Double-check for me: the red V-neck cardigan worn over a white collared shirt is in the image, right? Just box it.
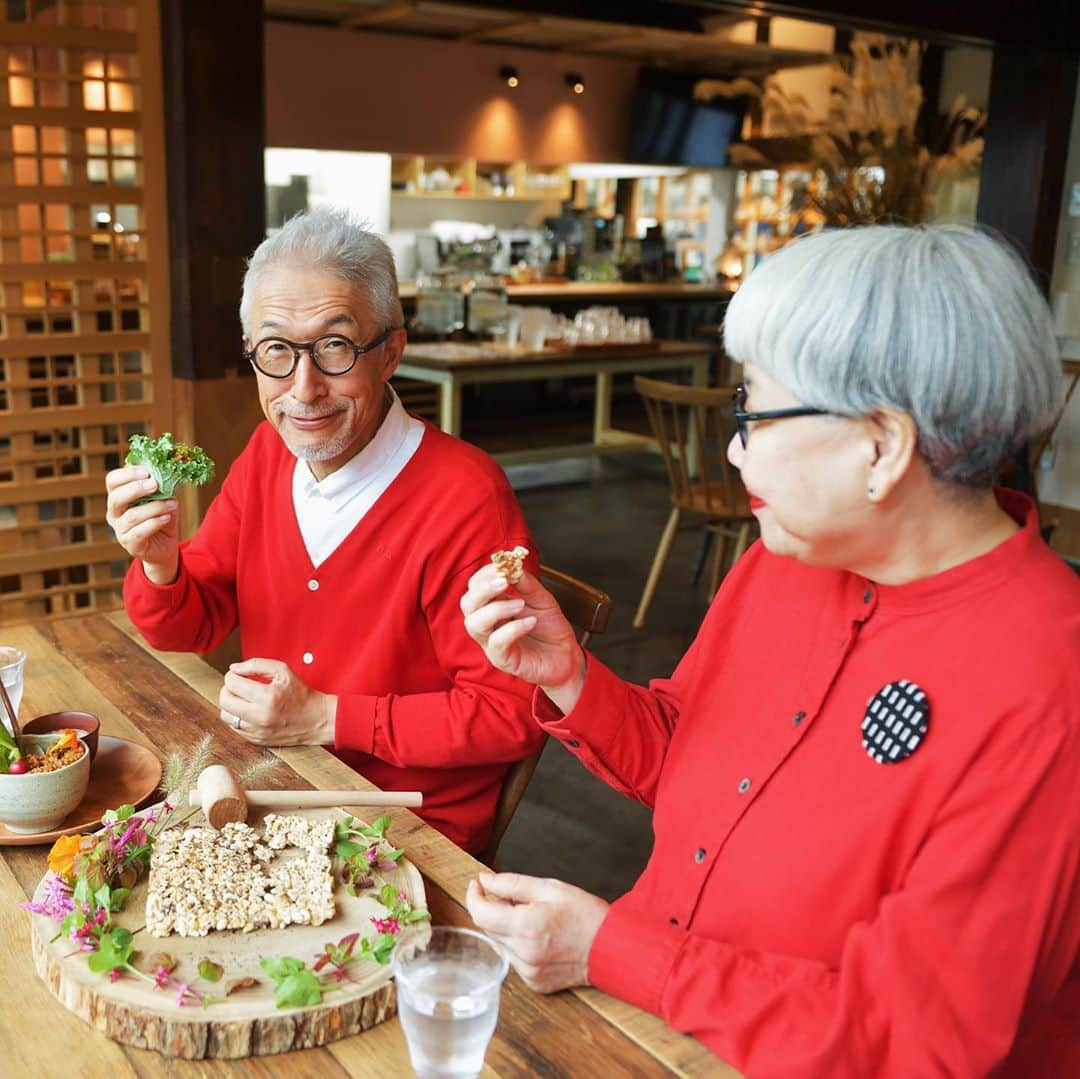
[124,422,542,851]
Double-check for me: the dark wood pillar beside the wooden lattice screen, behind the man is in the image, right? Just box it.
[161,0,266,379]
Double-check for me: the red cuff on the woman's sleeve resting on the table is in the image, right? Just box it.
[589,898,687,1016]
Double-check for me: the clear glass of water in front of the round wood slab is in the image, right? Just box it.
[393,926,510,1079]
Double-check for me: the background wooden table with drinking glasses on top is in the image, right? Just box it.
[397,341,708,464]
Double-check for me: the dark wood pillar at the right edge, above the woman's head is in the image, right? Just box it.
[977,45,1078,291]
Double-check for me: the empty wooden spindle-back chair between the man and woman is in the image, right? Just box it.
[634,376,754,630]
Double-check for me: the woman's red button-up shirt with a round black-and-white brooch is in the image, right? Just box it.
[534,493,1080,1079]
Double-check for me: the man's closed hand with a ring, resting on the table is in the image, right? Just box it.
[218,659,337,745]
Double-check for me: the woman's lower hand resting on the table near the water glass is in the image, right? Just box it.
[465,873,608,993]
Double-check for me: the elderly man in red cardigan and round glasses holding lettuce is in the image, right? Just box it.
[106,211,540,851]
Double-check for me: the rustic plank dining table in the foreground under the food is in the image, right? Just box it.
[0,612,737,1079]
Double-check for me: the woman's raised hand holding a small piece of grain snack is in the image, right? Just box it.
[461,566,585,713]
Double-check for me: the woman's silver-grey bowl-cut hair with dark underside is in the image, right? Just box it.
[724,226,1064,487]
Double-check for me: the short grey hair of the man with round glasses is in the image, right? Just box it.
[240,207,405,337]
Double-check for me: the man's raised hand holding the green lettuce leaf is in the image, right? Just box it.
[105,466,180,584]
